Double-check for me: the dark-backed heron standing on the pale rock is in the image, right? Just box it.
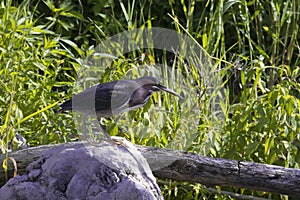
[60,76,182,139]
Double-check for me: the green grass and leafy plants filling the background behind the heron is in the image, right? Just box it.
[0,0,300,199]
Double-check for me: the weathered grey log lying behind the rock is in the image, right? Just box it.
[0,143,300,196]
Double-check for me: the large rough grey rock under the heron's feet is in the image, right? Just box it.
[0,139,163,200]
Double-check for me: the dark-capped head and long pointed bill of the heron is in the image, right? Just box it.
[136,76,183,99]
